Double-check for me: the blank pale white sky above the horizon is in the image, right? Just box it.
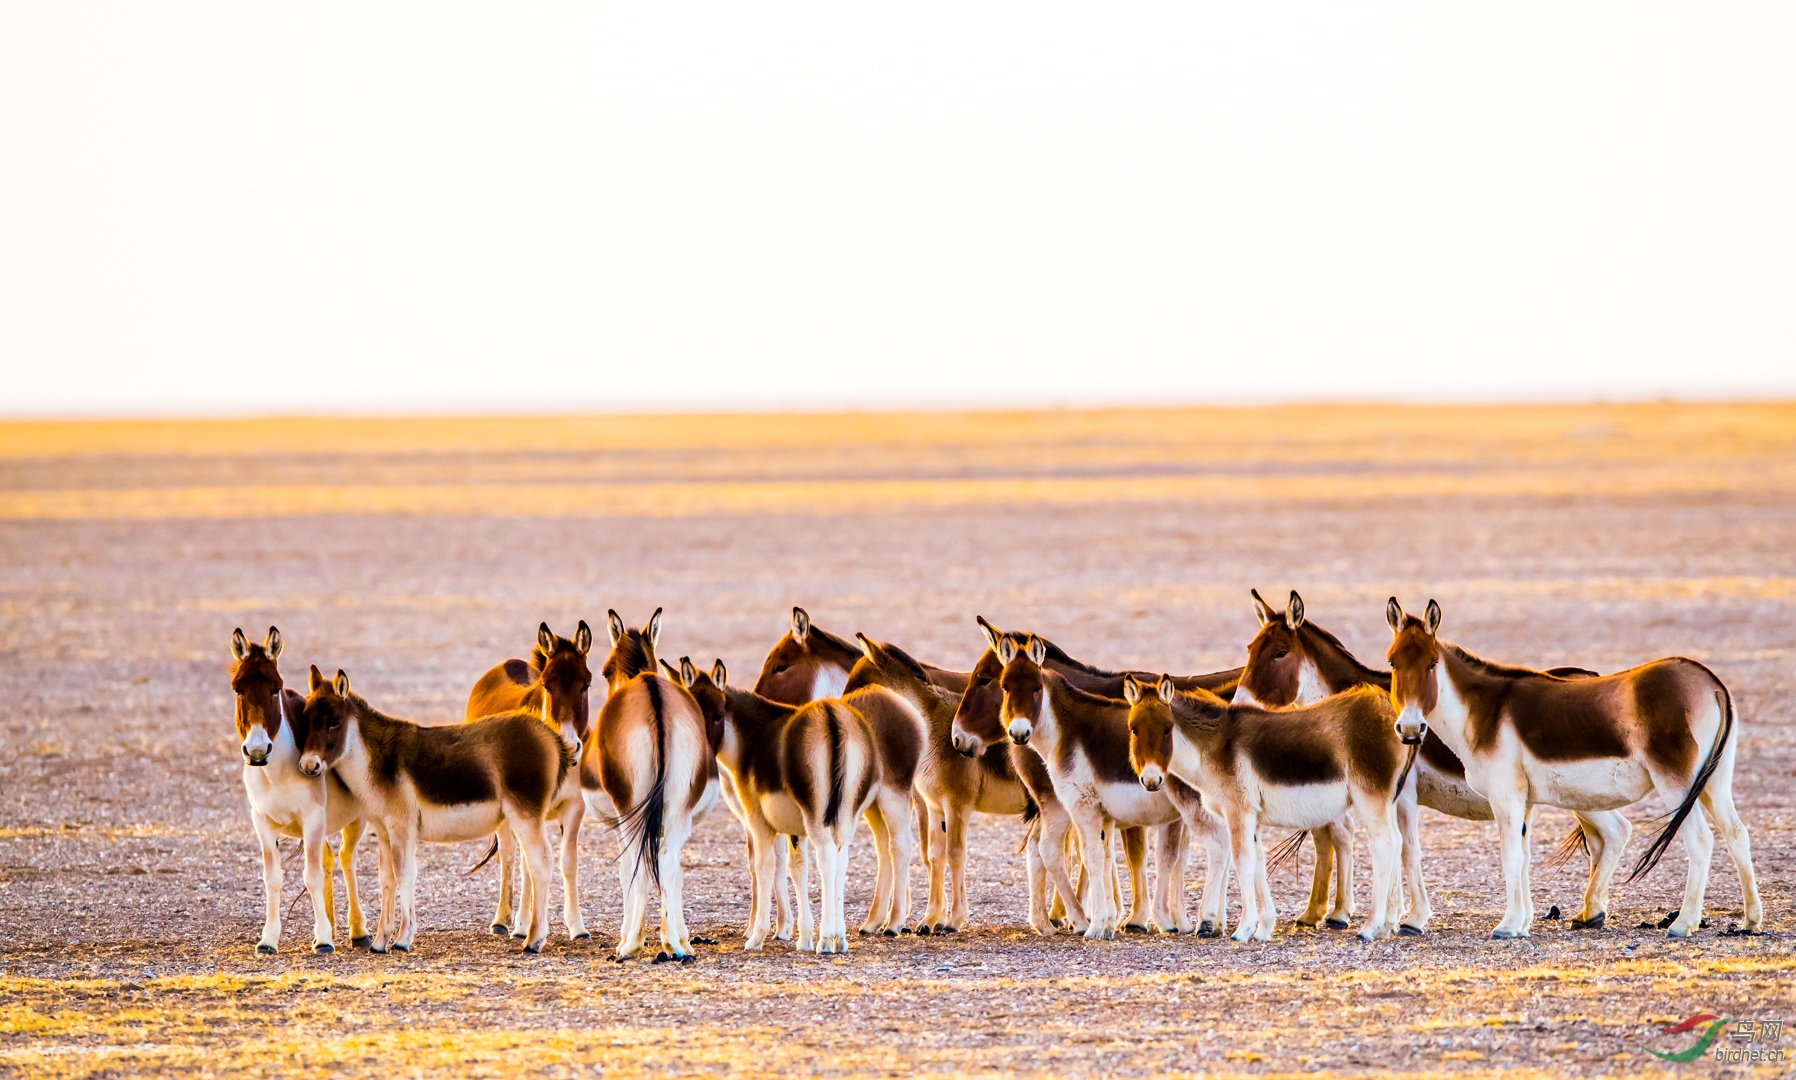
[0,0,1796,415]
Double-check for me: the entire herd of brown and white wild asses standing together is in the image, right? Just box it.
[232,591,1762,960]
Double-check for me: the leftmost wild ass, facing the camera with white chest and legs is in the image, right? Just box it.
[230,627,368,952]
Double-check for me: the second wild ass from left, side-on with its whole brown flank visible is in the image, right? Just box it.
[300,667,575,952]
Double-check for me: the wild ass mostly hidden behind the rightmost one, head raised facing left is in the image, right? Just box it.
[1234,589,1633,934]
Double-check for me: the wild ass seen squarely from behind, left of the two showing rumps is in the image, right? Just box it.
[580,607,718,963]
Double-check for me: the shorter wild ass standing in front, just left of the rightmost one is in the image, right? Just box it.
[1123,676,1422,942]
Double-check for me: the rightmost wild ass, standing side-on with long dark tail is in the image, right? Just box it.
[1385,597,1764,938]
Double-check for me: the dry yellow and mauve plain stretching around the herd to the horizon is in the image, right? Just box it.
[0,404,1796,1078]
